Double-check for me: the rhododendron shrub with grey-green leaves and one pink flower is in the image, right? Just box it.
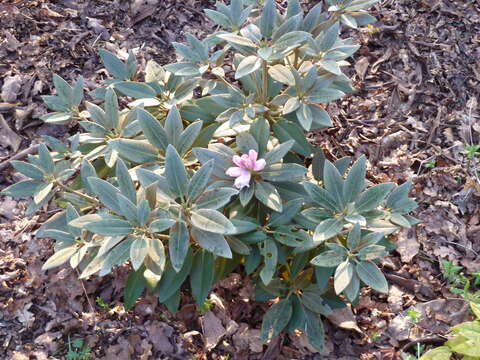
[2,0,416,350]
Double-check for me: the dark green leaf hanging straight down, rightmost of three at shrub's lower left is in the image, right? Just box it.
[190,250,214,306]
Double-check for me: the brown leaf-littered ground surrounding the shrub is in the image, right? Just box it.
[0,0,480,360]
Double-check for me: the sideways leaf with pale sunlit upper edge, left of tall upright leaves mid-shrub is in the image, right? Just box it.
[108,139,158,164]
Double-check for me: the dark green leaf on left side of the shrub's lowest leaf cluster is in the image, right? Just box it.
[260,299,292,342]
